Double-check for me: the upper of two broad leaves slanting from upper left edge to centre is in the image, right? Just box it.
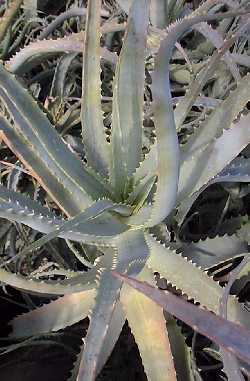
[0,66,112,214]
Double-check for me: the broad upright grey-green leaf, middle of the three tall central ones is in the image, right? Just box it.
[111,0,149,196]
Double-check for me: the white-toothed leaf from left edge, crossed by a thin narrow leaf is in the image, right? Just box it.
[0,185,128,246]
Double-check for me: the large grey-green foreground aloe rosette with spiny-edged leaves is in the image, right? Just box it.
[0,0,250,381]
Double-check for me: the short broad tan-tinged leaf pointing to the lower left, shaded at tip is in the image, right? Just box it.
[10,289,96,339]
